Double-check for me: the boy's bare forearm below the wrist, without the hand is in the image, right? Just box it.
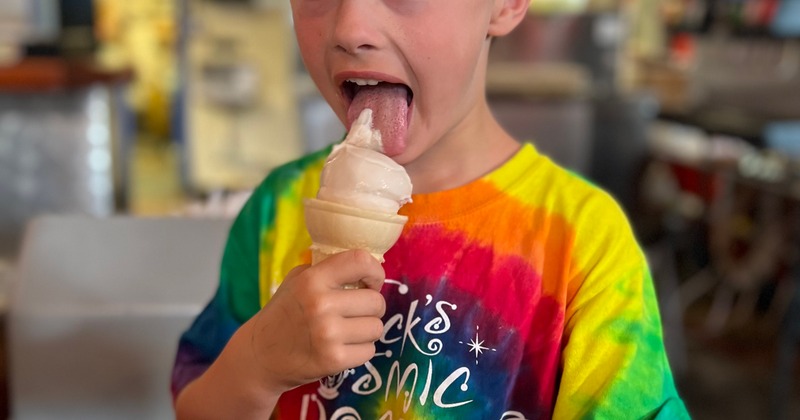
[175,323,281,420]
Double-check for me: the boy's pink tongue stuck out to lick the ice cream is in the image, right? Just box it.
[347,83,408,156]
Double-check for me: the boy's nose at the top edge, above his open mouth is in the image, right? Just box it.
[333,0,378,55]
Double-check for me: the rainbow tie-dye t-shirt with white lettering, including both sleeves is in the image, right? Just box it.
[172,144,689,420]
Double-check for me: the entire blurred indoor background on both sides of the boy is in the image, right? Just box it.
[0,0,800,419]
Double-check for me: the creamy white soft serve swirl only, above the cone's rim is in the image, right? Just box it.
[317,108,411,213]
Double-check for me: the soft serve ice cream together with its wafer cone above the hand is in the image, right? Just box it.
[305,108,411,264]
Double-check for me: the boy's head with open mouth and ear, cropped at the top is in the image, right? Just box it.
[291,0,530,168]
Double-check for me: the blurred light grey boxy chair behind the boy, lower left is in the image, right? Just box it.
[7,217,230,420]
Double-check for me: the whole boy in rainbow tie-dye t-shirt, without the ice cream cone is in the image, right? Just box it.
[173,0,688,419]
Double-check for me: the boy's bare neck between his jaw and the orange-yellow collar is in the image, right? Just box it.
[405,102,520,194]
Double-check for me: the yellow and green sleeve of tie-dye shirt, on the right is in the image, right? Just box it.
[554,195,689,419]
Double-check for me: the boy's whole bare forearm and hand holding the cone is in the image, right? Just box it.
[175,251,386,419]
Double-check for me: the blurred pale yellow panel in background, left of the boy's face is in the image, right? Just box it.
[186,1,303,190]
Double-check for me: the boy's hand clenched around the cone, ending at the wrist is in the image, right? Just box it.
[248,251,386,390]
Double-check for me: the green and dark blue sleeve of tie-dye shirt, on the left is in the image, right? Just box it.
[171,190,270,399]
